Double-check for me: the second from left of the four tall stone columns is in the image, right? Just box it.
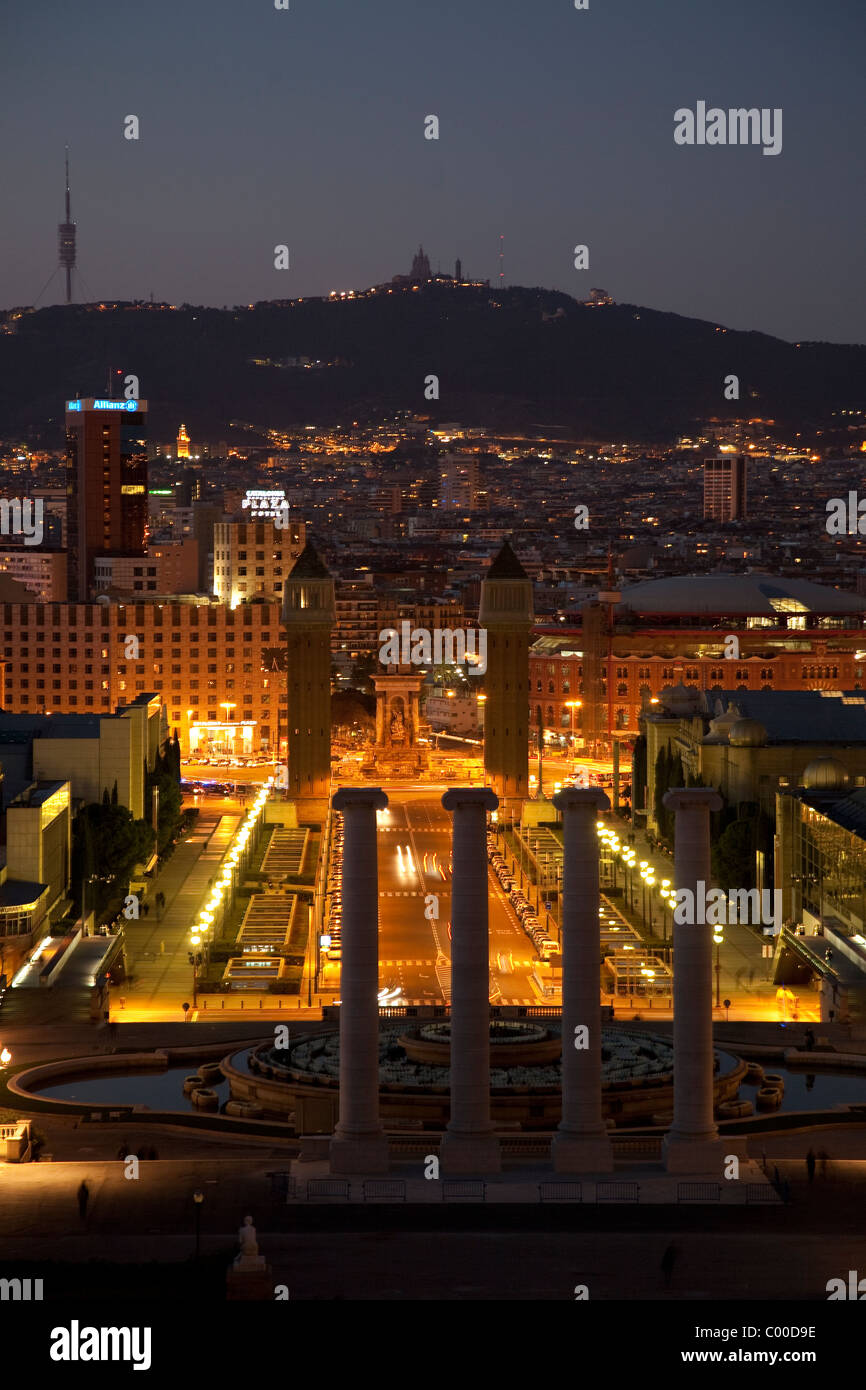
[439,787,500,1173]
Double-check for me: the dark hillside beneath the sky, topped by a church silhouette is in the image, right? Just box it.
[0,285,866,445]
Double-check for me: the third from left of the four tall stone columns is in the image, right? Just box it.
[550,787,613,1173]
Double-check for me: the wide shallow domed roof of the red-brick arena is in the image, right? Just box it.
[617,573,866,616]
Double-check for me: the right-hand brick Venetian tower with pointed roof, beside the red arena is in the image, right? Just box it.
[478,541,532,803]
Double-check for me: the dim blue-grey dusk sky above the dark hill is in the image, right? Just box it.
[0,0,866,342]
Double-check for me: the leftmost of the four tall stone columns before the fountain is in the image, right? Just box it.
[329,787,388,1173]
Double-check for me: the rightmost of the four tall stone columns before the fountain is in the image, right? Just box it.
[663,787,730,1173]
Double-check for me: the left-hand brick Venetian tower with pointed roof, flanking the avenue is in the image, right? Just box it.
[282,541,336,820]
